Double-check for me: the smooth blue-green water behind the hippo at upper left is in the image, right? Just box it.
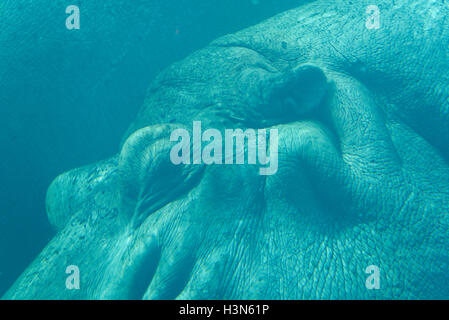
[0,0,307,296]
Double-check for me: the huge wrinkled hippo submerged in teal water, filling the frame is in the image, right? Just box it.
[4,1,449,299]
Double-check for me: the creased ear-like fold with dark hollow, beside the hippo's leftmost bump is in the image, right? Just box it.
[119,124,203,227]
